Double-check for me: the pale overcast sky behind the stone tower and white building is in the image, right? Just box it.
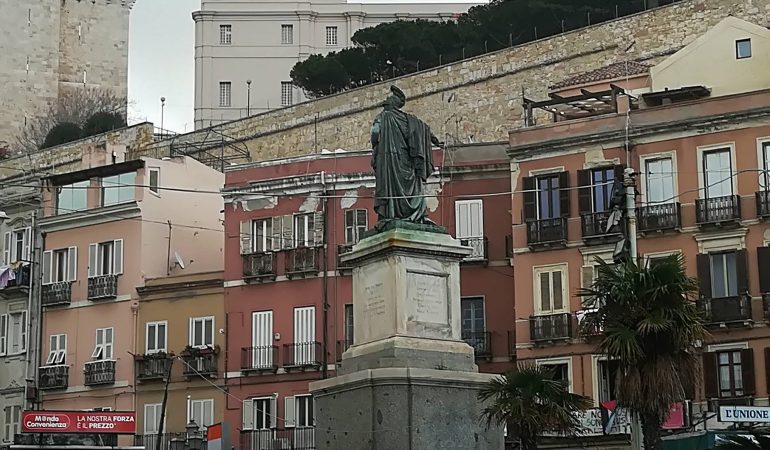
[128,0,486,132]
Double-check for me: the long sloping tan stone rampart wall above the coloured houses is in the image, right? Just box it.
[136,0,770,165]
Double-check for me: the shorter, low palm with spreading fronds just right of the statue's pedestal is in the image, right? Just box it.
[479,364,592,450]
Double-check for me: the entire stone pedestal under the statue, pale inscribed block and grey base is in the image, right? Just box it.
[310,225,503,450]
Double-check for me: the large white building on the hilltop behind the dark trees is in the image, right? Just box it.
[193,0,473,129]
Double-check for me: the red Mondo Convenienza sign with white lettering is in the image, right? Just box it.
[21,411,136,434]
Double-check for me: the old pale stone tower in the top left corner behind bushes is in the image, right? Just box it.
[0,0,135,146]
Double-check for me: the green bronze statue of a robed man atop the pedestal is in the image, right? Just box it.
[372,86,441,223]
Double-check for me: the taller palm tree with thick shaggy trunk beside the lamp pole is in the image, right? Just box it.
[580,255,707,450]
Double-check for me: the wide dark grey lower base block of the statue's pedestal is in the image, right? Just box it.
[310,368,504,450]
